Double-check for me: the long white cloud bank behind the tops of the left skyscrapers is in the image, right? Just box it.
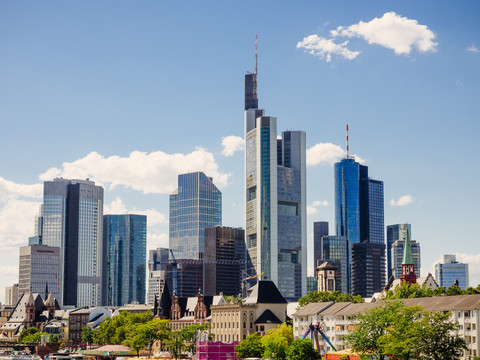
[40,148,230,194]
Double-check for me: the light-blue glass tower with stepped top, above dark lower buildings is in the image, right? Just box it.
[169,172,222,259]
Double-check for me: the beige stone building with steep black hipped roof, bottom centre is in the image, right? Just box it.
[211,280,287,343]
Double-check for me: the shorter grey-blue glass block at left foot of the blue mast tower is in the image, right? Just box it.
[319,235,350,294]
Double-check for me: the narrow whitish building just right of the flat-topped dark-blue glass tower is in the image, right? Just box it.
[147,248,169,304]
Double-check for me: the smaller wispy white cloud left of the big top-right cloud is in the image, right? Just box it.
[297,34,360,62]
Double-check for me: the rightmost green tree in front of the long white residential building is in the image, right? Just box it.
[413,311,467,360]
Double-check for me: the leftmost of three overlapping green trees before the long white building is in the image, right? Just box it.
[344,301,404,359]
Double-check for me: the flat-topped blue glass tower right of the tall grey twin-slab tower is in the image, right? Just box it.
[102,214,147,306]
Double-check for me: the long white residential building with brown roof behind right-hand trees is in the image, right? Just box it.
[292,294,480,360]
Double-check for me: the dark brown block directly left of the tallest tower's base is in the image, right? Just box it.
[205,226,247,296]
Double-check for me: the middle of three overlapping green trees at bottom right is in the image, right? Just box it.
[378,306,422,360]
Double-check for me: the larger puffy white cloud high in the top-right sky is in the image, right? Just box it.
[330,11,438,54]
